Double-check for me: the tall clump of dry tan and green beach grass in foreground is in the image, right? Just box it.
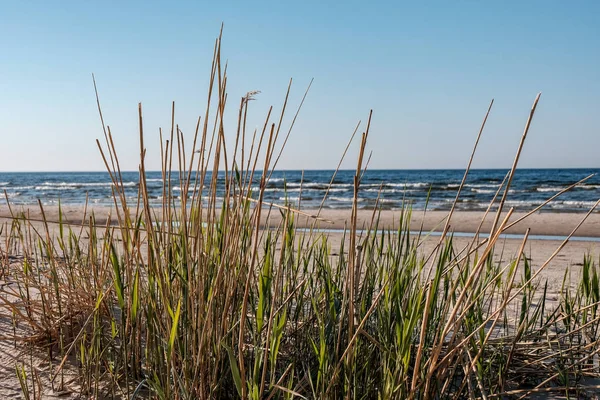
[0,32,600,399]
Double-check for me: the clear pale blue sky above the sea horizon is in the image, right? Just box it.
[0,0,600,171]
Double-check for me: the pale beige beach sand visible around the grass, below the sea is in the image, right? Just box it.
[0,205,600,399]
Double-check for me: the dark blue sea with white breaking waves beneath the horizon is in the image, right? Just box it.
[0,169,600,212]
